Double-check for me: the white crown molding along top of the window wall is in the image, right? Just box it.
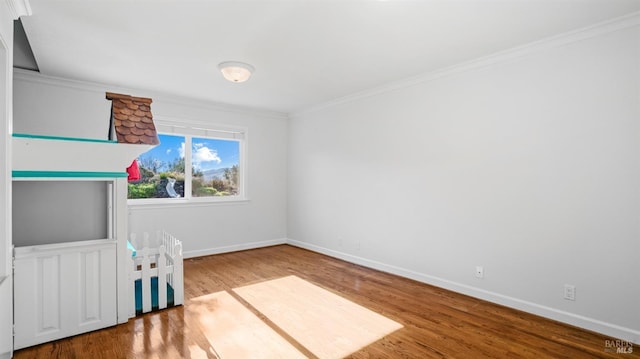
[13,68,288,119]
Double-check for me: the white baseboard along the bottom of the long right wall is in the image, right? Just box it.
[286,239,640,346]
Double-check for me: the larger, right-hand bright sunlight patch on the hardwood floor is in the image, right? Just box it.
[234,276,402,359]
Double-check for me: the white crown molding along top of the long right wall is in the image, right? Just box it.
[289,12,640,119]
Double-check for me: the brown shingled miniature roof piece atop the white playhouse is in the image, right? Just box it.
[107,92,160,145]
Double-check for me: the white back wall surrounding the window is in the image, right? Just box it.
[14,71,287,256]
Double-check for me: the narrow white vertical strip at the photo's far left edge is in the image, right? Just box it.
[0,1,13,358]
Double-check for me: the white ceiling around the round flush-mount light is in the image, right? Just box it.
[22,0,640,113]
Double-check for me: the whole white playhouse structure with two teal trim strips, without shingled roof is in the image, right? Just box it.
[11,134,153,349]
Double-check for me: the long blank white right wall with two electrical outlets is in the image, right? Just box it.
[288,17,640,343]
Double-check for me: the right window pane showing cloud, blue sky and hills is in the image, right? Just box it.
[191,137,241,197]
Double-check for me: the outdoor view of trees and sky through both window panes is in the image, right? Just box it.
[128,135,240,199]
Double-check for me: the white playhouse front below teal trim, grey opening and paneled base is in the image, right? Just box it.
[12,179,118,349]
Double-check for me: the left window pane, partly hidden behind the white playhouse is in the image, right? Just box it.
[128,135,185,198]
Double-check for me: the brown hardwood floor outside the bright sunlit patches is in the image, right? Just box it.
[14,245,640,359]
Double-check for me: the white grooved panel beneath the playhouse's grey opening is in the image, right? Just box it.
[14,240,117,349]
